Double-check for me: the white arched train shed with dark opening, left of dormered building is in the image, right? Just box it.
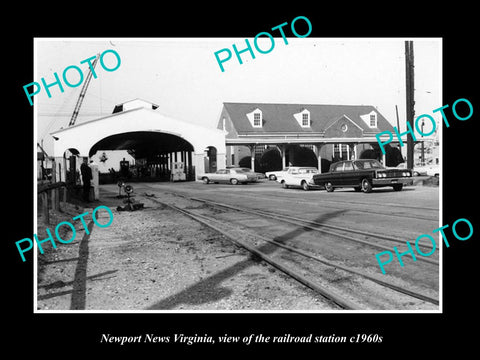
[51,99,225,188]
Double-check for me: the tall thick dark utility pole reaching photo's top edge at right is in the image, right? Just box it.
[405,41,415,169]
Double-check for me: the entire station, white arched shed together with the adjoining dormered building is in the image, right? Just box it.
[47,99,403,193]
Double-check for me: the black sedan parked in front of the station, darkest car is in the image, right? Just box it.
[313,159,413,193]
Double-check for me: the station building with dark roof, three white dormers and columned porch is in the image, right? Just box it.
[217,102,403,172]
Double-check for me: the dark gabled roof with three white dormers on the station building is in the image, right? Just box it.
[223,102,393,135]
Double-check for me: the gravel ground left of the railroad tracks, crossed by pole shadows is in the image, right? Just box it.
[37,193,338,311]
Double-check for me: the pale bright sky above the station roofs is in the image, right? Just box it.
[34,37,444,154]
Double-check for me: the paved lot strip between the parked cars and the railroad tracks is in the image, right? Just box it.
[126,181,441,241]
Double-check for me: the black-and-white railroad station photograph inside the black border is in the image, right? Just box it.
[33,37,442,312]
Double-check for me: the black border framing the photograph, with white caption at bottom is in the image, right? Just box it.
[6,3,480,356]
